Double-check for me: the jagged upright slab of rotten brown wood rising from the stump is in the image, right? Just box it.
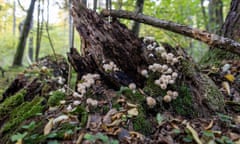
[72,0,147,86]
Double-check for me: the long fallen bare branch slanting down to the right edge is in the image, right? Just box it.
[102,10,240,55]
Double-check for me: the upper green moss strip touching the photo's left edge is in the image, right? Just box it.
[0,90,26,121]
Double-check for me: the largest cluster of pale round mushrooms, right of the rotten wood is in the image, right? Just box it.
[140,37,179,103]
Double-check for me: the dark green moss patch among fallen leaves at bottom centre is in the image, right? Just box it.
[132,106,152,135]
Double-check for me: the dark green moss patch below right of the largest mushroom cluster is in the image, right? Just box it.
[171,85,194,116]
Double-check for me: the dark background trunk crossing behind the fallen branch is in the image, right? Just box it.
[132,0,144,36]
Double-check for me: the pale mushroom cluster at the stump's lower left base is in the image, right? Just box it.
[76,73,100,98]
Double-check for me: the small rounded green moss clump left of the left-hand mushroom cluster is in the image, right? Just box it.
[48,91,65,106]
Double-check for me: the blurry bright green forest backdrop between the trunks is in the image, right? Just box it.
[0,0,230,68]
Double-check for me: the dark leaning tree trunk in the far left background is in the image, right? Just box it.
[13,0,36,66]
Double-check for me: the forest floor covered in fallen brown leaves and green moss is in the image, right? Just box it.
[0,55,240,144]
